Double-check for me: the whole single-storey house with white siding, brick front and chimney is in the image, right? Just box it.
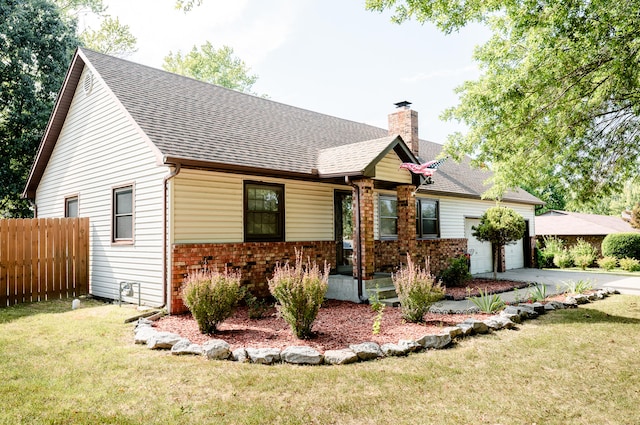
[24,49,541,312]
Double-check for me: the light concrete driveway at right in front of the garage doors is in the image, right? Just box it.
[474,269,640,295]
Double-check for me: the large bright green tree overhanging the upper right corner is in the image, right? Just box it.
[367,0,640,199]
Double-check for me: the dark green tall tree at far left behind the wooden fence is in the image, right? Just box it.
[0,0,78,217]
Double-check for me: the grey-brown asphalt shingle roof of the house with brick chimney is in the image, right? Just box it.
[25,49,541,204]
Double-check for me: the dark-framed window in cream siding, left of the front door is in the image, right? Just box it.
[244,182,284,242]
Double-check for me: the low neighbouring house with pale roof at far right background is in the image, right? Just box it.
[535,210,640,254]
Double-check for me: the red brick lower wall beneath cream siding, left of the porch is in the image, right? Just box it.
[171,241,336,314]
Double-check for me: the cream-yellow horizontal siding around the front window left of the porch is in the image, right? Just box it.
[171,169,345,243]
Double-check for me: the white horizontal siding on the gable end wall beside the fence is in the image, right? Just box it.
[36,69,169,305]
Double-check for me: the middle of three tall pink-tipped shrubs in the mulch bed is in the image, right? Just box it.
[269,249,329,338]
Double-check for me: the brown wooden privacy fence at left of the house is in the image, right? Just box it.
[0,218,89,308]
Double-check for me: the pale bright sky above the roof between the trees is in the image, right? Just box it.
[90,0,489,143]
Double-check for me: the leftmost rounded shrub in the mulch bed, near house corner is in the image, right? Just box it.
[182,269,244,334]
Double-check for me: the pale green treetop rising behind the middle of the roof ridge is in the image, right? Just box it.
[162,41,258,94]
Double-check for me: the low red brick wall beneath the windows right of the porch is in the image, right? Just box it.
[375,239,467,274]
